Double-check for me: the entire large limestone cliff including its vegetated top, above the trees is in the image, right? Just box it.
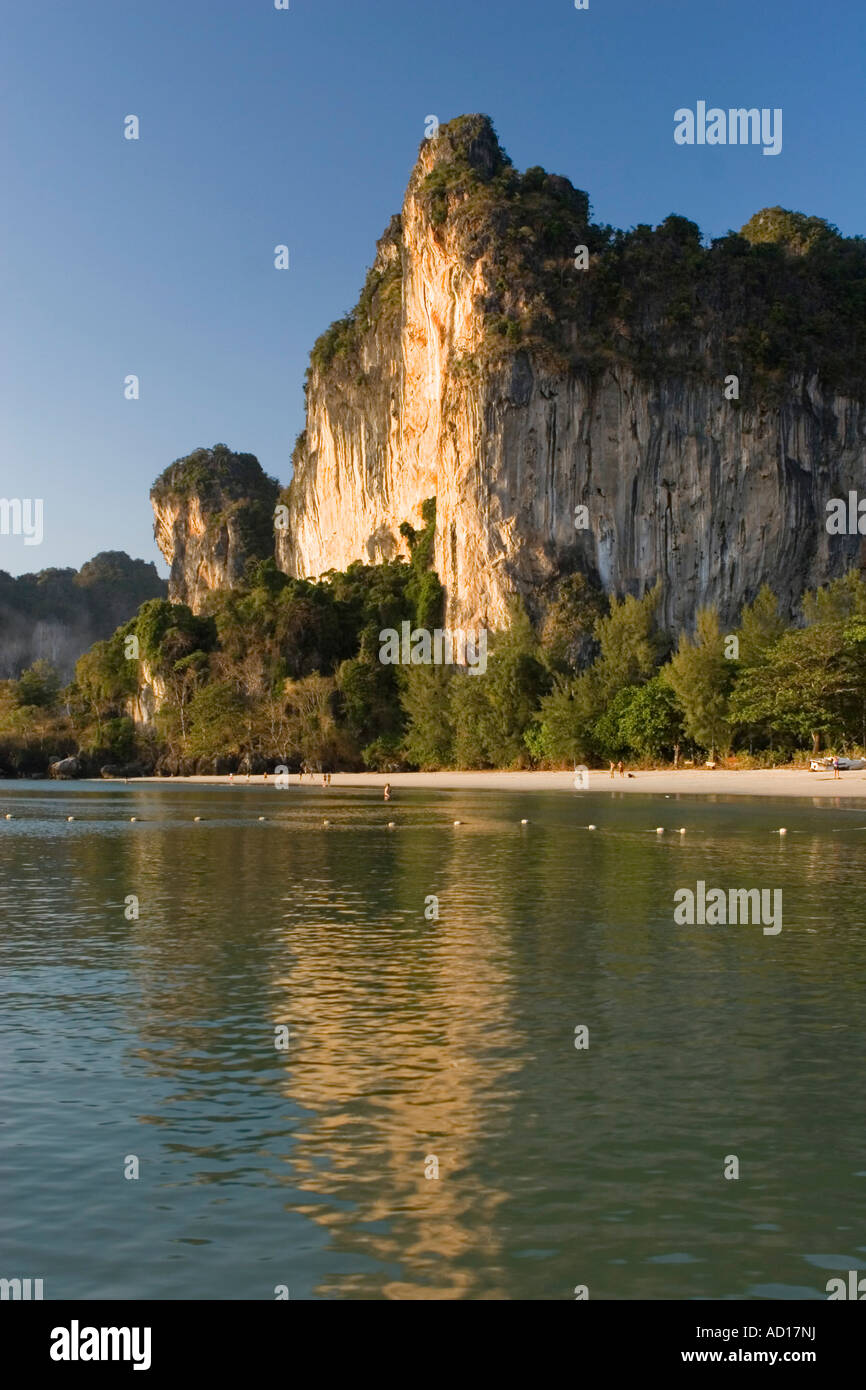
[276,117,866,626]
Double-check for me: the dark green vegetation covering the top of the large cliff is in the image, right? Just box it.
[304,115,866,399]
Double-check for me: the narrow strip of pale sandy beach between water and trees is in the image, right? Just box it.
[136,767,866,799]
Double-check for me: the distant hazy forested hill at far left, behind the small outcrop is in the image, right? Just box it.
[0,550,165,680]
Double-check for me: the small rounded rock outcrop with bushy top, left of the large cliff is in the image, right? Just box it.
[150,445,278,613]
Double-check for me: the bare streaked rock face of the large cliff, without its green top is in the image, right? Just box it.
[277,116,866,627]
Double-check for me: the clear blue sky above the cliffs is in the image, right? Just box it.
[0,0,866,574]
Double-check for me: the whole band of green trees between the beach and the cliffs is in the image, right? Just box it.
[6,525,866,774]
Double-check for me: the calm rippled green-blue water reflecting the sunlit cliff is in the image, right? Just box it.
[0,783,866,1300]
